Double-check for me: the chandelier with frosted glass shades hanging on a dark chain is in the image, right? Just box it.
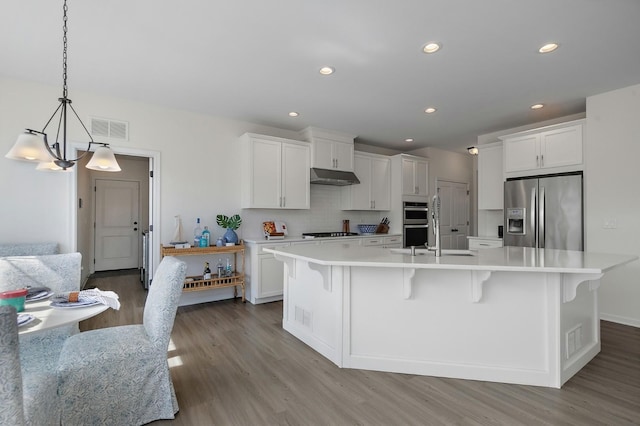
[5,0,121,172]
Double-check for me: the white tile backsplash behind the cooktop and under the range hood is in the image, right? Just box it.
[239,185,380,239]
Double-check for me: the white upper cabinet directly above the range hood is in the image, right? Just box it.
[300,127,355,172]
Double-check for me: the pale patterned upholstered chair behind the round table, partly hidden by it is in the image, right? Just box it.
[0,253,82,426]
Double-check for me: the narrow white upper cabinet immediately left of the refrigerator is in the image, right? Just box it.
[478,142,504,210]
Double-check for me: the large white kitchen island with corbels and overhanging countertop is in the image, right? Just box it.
[264,245,637,388]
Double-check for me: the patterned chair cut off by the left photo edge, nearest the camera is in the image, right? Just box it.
[0,306,24,426]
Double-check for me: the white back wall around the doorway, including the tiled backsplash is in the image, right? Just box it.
[0,78,384,262]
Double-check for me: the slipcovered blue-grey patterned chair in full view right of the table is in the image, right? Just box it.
[57,256,186,425]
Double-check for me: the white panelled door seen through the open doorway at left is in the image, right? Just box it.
[95,179,140,271]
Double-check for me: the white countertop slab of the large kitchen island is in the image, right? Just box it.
[264,244,638,274]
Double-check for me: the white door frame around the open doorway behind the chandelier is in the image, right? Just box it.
[67,143,162,284]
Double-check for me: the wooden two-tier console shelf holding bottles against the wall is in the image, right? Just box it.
[160,244,245,302]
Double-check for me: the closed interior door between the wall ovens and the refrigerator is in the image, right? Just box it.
[438,180,469,250]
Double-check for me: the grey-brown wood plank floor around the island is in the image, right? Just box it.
[80,274,640,426]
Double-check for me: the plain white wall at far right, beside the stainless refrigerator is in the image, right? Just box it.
[585,85,640,327]
